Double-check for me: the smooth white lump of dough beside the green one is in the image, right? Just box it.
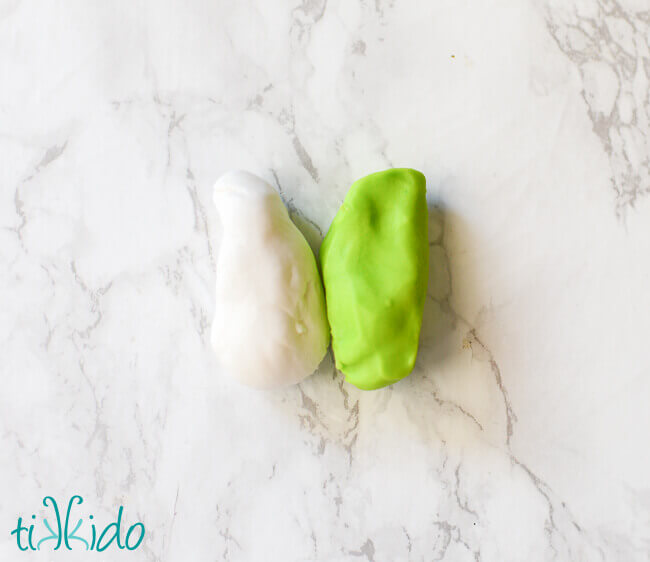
[211,171,330,388]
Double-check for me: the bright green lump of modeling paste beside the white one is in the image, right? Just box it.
[320,168,429,390]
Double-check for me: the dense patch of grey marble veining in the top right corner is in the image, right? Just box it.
[547,0,650,215]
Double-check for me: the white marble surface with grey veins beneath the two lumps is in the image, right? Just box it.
[0,0,650,562]
